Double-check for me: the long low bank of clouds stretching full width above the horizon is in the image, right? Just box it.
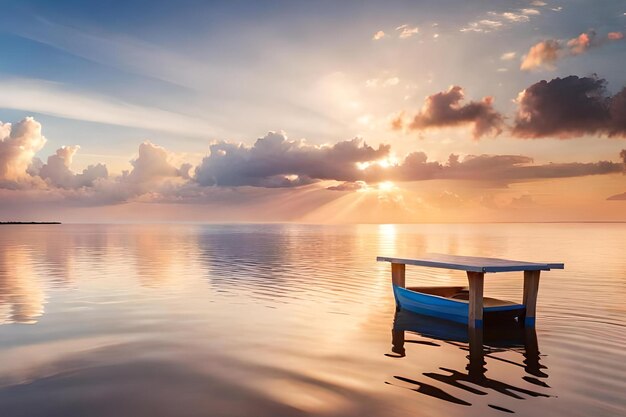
[0,118,626,210]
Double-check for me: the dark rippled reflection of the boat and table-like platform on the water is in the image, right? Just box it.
[385,311,550,413]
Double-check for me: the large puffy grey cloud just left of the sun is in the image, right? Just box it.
[195,132,390,188]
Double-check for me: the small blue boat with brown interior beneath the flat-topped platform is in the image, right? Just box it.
[393,285,526,324]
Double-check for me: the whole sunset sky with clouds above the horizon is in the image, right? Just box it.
[0,0,626,223]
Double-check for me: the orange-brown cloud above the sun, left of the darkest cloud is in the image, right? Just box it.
[394,86,503,139]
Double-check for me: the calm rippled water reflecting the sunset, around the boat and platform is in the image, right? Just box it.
[0,224,626,417]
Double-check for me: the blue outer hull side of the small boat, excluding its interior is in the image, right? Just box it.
[393,285,526,324]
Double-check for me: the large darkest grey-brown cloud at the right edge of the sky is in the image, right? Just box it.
[512,75,626,139]
